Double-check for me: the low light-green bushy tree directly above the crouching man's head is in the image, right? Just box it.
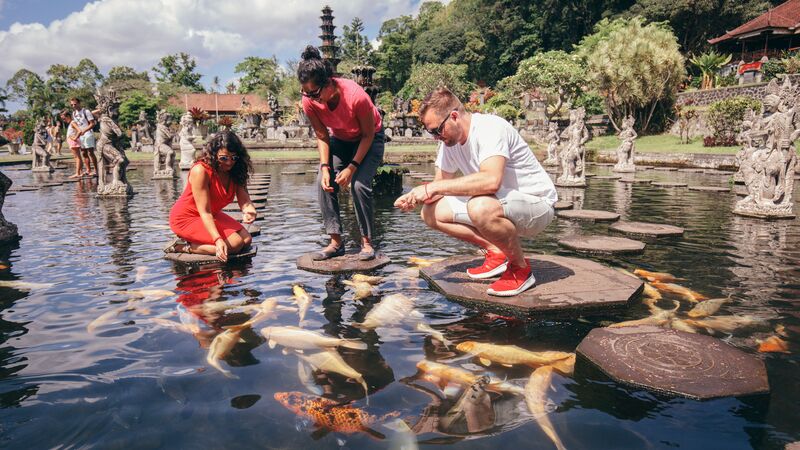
[398,64,473,101]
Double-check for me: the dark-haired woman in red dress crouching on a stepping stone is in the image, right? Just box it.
[164,131,256,261]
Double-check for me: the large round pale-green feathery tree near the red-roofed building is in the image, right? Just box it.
[578,17,685,131]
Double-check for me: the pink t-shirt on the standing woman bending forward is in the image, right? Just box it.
[303,78,382,141]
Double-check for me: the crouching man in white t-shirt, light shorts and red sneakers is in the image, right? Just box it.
[395,88,558,296]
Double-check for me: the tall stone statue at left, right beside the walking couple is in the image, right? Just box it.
[95,90,133,196]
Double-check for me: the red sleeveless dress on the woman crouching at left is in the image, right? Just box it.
[169,161,244,245]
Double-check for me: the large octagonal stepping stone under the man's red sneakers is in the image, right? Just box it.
[420,254,644,317]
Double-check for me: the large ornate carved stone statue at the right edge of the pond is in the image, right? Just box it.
[733,77,800,218]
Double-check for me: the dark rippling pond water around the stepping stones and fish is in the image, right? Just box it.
[0,164,800,449]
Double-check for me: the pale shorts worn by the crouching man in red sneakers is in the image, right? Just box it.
[443,190,555,237]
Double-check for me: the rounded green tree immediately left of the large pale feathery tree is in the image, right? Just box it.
[502,50,587,120]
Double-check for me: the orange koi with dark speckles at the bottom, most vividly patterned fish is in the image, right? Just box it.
[274,392,396,439]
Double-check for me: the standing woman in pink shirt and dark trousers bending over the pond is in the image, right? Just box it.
[297,45,384,261]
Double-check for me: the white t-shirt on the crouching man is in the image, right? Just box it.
[436,113,558,206]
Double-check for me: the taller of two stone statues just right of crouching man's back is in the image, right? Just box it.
[555,108,591,187]
